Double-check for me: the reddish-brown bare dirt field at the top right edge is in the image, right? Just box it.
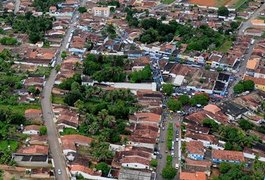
[188,0,245,8]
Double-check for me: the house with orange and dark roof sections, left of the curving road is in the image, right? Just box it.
[12,145,49,167]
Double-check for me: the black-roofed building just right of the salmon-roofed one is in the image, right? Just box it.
[219,101,248,121]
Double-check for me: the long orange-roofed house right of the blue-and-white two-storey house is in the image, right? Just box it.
[212,150,245,164]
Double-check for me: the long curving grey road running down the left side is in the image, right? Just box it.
[41,1,84,180]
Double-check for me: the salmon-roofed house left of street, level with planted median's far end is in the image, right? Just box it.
[129,112,161,126]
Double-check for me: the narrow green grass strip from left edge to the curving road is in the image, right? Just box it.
[0,103,41,115]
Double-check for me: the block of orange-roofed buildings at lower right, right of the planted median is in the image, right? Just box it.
[177,91,265,179]
